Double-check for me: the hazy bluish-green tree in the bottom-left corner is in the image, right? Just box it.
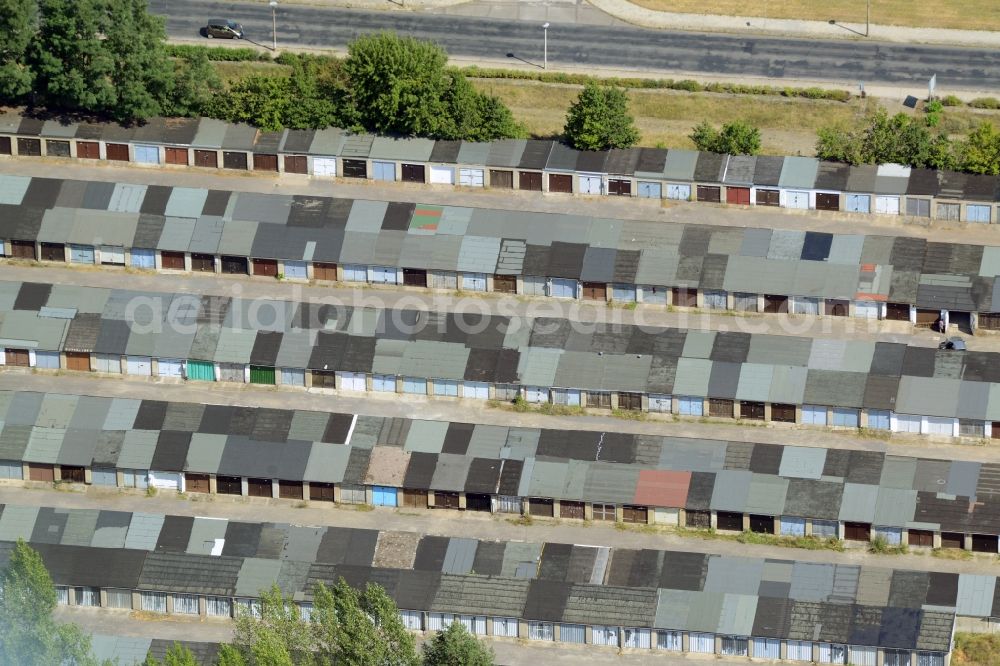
[0,539,97,666]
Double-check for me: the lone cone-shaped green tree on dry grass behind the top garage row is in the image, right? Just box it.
[563,83,639,150]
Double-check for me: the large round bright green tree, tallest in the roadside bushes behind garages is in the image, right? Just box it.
[344,33,448,136]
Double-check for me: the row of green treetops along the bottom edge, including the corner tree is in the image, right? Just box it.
[0,539,493,666]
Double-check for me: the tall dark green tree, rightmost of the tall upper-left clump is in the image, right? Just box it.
[103,0,174,122]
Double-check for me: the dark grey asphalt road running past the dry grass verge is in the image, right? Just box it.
[150,0,1000,89]
